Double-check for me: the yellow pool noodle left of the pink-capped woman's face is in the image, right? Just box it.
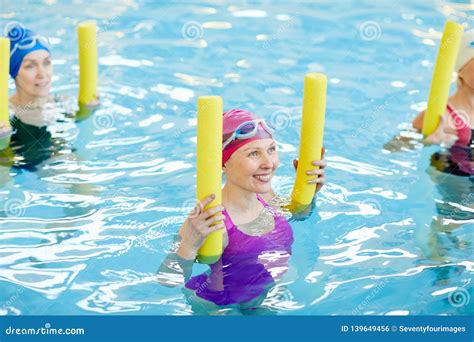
[196,96,223,264]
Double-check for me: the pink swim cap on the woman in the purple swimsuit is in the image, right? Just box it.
[222,109,273,166]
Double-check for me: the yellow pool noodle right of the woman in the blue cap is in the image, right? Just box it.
[77,21,99,104]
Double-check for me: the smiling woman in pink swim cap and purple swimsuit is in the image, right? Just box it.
[159,109,325,313]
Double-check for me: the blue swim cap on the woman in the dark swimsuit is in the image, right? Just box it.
[5,23,49,78]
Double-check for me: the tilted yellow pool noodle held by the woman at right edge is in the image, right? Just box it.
[422,21,464,137]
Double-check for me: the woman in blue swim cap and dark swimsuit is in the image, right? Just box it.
[0,22,96,169]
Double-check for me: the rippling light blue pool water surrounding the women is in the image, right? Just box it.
[0,0,474,315]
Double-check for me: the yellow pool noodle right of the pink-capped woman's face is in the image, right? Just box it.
[290,73,327,211]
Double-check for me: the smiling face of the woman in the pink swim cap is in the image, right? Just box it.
[224,139,280,193]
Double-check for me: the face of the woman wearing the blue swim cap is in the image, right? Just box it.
[15,50,53,97]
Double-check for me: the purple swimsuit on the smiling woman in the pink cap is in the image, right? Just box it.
[186,195,293,305]
